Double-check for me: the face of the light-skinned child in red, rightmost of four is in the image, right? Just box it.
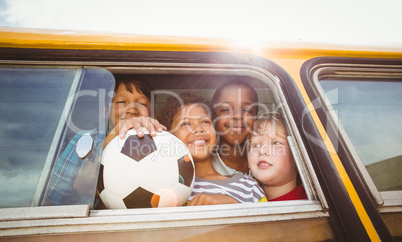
[247,122,297,186]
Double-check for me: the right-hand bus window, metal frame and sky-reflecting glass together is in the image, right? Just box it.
[306,58,402,205]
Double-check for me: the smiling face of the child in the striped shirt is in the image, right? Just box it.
[171,104,216,161]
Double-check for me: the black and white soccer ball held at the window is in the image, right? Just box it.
[98,128,195,209]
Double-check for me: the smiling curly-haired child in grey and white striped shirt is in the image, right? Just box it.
[158,93,266,206]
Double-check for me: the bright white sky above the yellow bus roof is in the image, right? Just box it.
[0,0,402,51]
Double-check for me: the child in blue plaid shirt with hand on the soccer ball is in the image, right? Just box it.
[44,79,166,205]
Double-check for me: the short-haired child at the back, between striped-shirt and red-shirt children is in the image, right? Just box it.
[212,81,258,175]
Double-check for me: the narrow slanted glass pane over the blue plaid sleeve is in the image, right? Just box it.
[41,69,115,208]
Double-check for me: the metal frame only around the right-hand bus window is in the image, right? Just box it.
[304,57,402,212]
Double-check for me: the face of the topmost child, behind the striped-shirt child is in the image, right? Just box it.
[215,85,256,145]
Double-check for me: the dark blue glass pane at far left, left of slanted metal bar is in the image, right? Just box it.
[0,68,77,207]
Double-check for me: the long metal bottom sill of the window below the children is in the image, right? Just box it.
[0,200,329,238]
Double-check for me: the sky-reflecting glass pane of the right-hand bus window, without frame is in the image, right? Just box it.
[320,79,402,191]
